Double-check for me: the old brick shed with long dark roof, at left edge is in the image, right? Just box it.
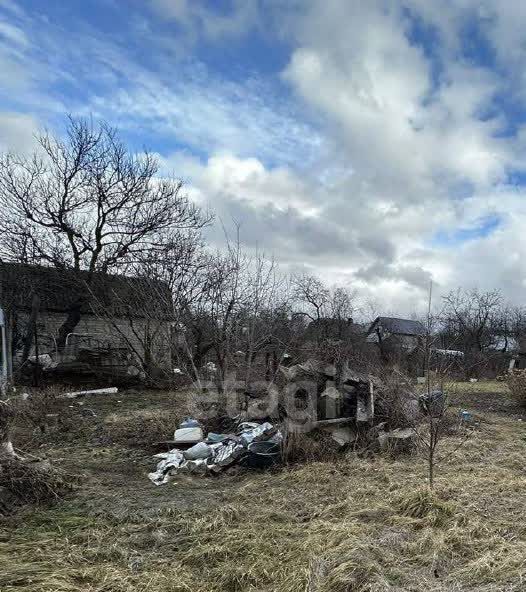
[0,263,172,382]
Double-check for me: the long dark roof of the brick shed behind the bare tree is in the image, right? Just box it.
[0,263,171,318]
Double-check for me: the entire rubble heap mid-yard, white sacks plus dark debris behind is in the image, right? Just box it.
[149,359,422,485]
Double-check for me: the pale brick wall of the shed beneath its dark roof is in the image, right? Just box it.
[16,312,171,367]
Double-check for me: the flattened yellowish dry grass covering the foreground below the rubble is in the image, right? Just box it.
[0,386,526,592]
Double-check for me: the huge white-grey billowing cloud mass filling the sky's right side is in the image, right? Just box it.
[157,1,524,311]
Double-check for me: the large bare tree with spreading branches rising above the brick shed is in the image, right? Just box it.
[0,118,209,349]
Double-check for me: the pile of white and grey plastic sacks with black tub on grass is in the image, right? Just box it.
[148,419,283,485]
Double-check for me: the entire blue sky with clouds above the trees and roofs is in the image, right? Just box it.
[0,0,526,312]
